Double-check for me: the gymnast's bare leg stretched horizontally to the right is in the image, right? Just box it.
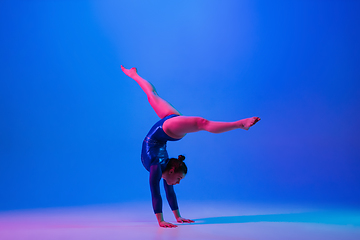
[163,116,260,138]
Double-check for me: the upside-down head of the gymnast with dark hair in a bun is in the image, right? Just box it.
[162,155,187,185]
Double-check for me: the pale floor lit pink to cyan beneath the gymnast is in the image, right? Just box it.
[0,202,360,240]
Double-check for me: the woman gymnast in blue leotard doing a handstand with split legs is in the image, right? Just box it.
[121,66,260,228]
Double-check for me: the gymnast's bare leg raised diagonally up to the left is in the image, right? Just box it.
[121,66,180,118]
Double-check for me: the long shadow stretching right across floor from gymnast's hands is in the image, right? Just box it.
[192,211,360,227]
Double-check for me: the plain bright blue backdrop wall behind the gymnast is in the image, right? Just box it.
[0,0,360,211]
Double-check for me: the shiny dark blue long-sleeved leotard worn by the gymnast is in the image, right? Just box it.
[141,114,180,213]
